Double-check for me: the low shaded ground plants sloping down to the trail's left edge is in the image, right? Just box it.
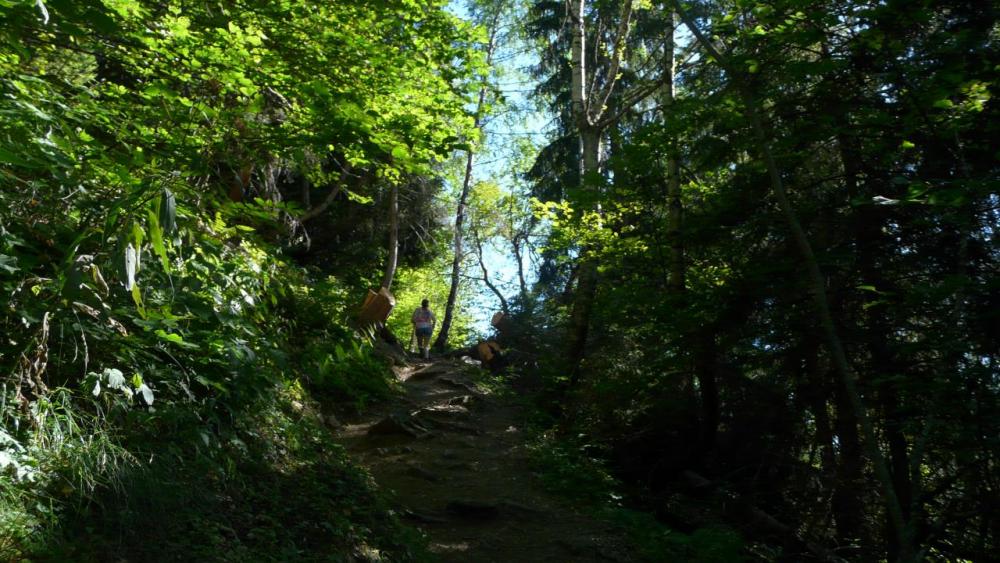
[37,386,423,561]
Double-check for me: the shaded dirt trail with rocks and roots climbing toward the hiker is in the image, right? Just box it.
[339,359,634,563]
